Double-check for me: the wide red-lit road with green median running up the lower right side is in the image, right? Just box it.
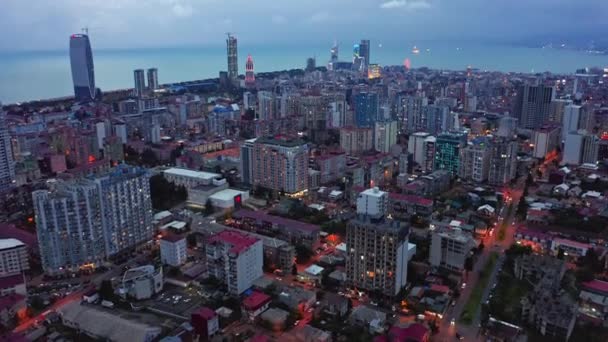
[432,177,525,342]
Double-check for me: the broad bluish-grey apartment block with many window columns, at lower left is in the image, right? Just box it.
[32,165,154,274]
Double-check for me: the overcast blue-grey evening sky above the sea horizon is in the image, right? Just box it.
[0,0,608,50]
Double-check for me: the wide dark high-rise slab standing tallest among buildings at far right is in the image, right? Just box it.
[514,84,555,129]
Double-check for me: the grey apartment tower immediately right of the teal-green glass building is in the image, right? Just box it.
[459,137,491,183]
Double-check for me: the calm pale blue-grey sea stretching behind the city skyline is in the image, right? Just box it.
[0,40,608,104]
